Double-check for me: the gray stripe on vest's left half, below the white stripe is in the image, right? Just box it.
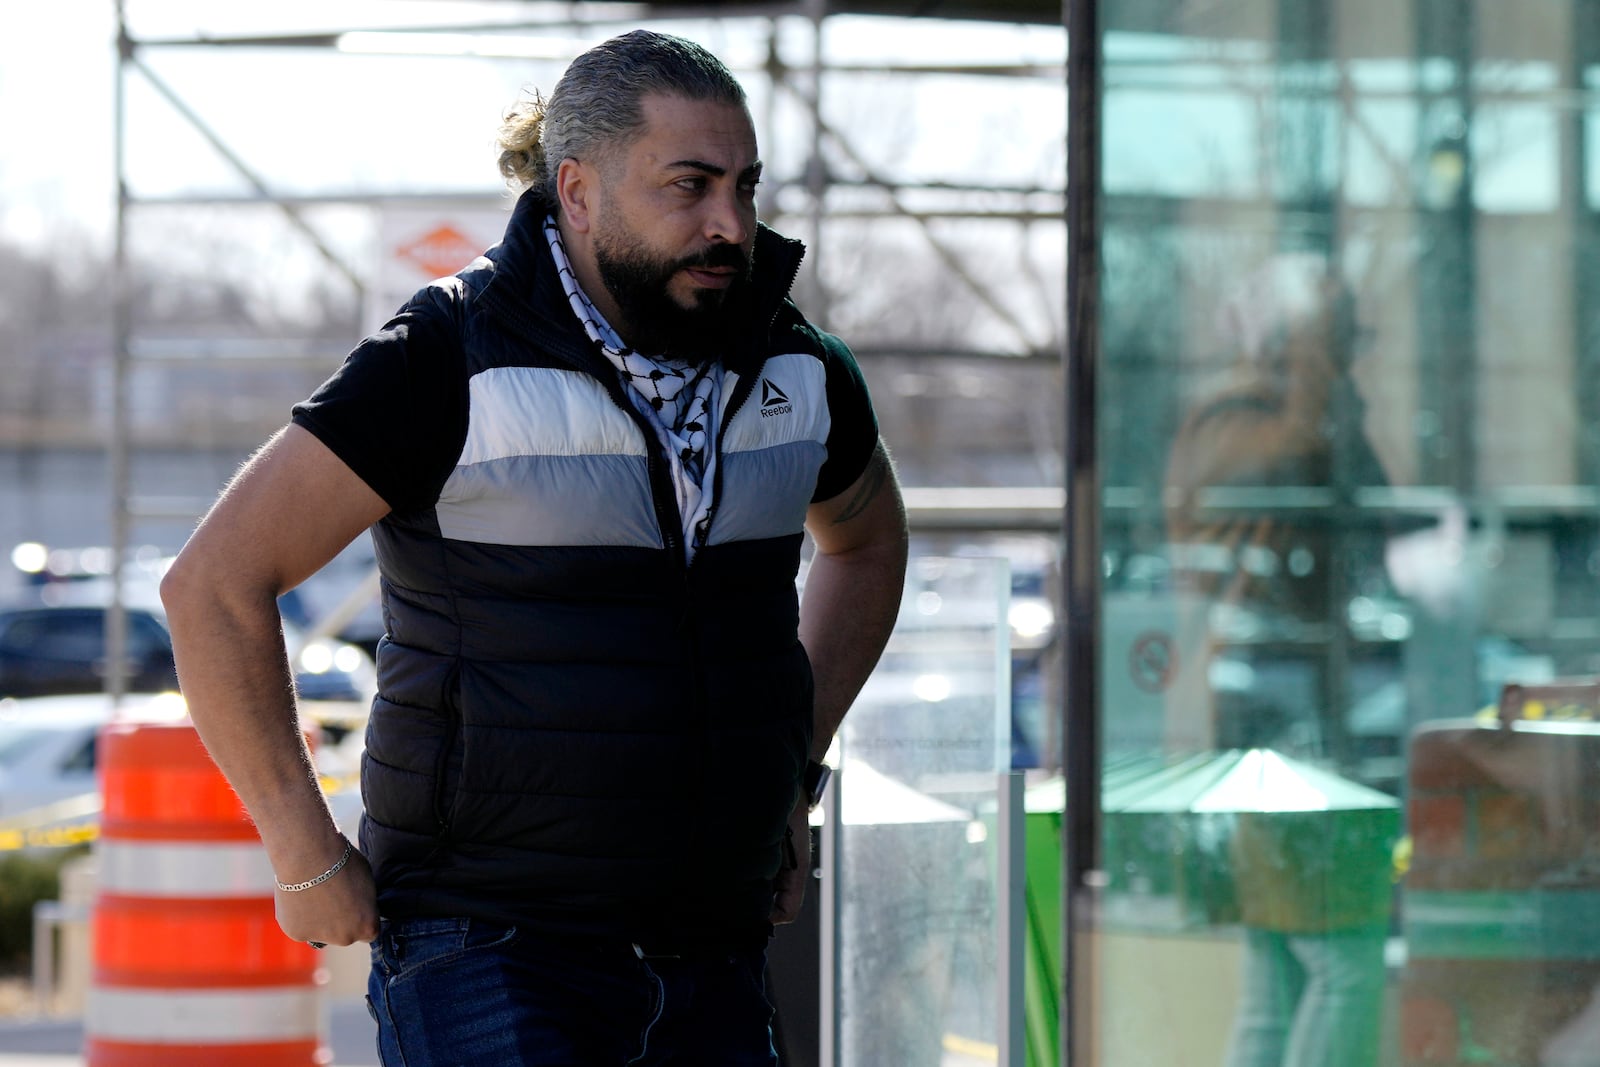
[435,456,661,549]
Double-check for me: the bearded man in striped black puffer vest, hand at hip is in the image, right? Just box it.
[162,32,906,1067]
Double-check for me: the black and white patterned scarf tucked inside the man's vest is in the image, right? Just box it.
[544,216,722,558]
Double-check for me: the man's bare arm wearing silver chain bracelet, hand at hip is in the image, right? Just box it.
[152,426,389,945]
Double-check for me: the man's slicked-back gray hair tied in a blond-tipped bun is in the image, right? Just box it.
[499,30,746,206]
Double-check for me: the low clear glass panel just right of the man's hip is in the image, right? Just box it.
[832,557,1011,1067]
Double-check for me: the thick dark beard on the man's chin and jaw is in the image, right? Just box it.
[595,229,750,363]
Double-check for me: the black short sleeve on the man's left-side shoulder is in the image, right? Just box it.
[291,291,467,512]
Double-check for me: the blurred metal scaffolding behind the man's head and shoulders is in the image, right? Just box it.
[107,0,1064,694]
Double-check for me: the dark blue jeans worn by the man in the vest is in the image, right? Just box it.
[366,918,778,1067]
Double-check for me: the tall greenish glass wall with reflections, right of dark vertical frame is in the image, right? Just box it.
[1094,0,1600,1067]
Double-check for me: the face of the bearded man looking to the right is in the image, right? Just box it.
[594,96,762,358]
